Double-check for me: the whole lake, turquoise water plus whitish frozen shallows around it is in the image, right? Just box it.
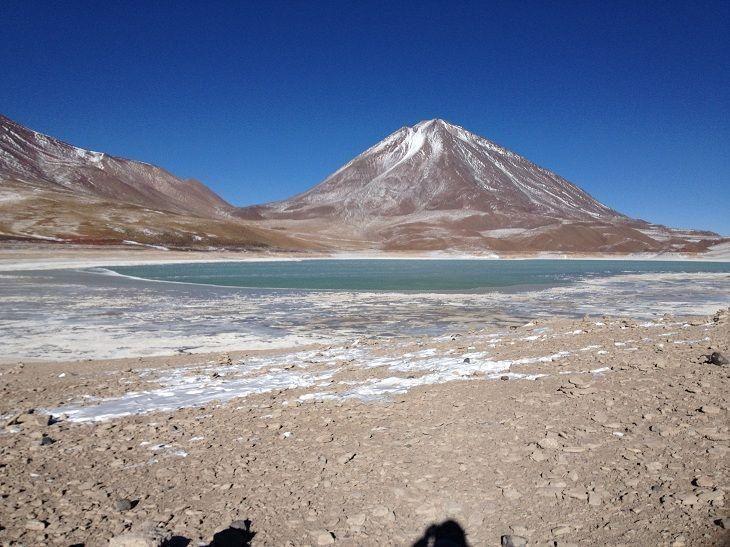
[0,260,730,362]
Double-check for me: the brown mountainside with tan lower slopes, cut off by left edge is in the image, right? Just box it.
[0,115,308,248]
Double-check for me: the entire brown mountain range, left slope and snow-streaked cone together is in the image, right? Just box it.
[0,116,730,253]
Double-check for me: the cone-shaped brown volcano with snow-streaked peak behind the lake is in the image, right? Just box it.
[236,120,717,252]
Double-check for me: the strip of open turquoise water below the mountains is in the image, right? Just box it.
[104,260,730,293]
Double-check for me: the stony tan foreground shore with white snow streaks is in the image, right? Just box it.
[0,314,730,546]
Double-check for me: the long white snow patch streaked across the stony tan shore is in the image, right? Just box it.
[49,346,569,422]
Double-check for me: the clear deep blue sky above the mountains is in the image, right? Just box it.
[0,0,730,234]
